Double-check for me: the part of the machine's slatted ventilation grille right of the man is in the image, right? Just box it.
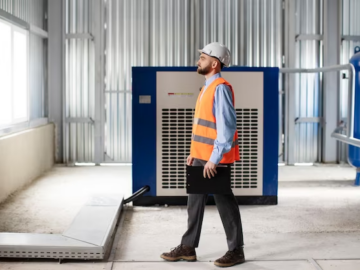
[231,109,259,189]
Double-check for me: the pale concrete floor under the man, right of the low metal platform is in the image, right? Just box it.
[110,175,360,270]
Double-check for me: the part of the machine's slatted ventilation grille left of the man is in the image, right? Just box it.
[161,109,195,189]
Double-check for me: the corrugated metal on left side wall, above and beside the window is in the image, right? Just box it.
[0,0,47,119]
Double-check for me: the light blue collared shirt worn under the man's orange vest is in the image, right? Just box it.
[200,73,237,164]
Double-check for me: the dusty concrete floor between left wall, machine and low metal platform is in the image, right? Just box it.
[0,166,132,234]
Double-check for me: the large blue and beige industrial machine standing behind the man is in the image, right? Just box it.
[132,67,279,206]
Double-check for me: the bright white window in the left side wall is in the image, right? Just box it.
[0,20,29,128]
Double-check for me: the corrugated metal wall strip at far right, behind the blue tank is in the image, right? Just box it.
[339,0,360,162]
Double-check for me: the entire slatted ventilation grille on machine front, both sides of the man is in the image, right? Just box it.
[162,109,259,189]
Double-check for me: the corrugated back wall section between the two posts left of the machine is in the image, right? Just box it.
[65,0,95,163]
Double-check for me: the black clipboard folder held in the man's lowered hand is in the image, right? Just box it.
[186,165,232,194]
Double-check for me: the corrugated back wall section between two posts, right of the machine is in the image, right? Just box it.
[294,0,323,163]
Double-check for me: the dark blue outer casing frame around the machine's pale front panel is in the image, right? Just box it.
[132,67,279,205]
